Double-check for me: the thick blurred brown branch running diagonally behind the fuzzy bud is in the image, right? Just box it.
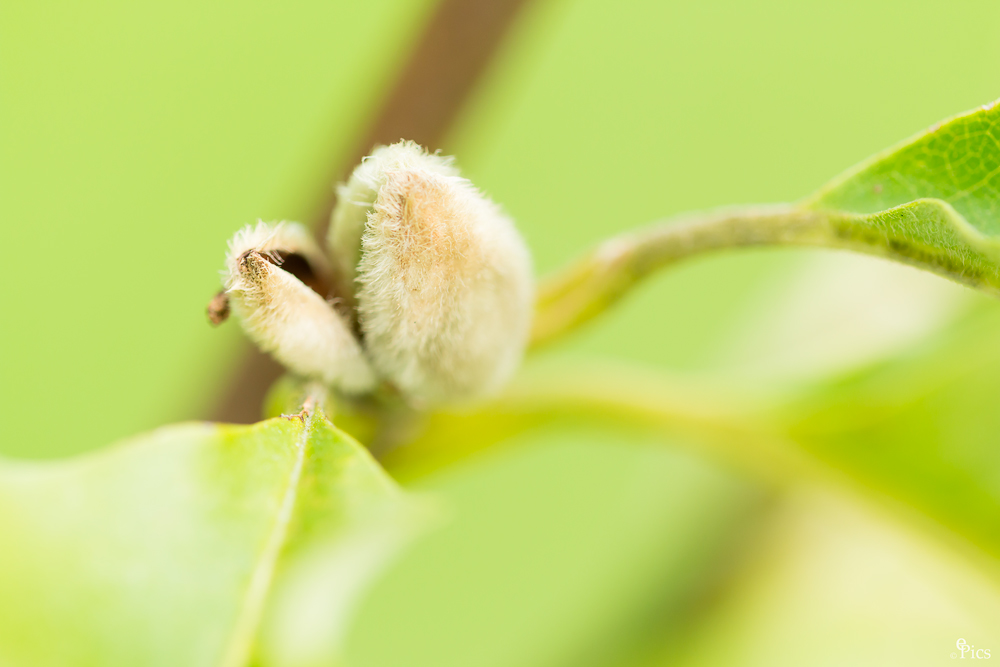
[211,0,527,423]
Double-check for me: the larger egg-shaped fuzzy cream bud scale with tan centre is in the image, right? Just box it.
[356,148,533,405]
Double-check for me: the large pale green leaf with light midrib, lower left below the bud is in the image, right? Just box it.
[0,412,414,667]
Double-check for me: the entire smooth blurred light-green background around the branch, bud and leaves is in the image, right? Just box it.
[0,0,1000,667]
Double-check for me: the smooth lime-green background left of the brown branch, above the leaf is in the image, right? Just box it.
[0,0,432,456]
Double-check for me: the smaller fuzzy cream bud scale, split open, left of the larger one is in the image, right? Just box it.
[225,223,376,393]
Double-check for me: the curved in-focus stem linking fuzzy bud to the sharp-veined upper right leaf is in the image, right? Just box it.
[531,199,1000,347]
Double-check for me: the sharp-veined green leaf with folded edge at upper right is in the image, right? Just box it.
[803,102,1000,295]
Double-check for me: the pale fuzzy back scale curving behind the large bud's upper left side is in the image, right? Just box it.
[327,141,458,286]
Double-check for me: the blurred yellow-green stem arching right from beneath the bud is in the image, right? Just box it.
[381,362,826,487]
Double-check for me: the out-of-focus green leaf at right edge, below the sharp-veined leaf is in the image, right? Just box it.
[789,308,1000,557]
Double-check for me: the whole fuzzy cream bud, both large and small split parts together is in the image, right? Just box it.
[216,142,534,407]
